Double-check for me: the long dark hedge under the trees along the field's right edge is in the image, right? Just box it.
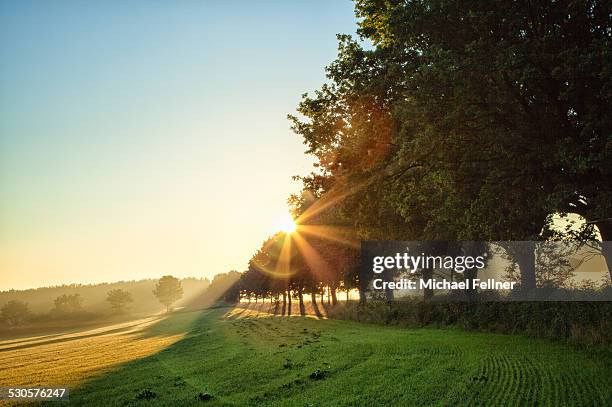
[329,300,612,346]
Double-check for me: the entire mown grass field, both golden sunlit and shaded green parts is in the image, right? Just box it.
[0,308,612,406]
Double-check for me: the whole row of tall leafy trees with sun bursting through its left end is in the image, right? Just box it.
[239,0,612,304]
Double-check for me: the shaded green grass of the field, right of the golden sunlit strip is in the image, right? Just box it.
[39,303,609,407]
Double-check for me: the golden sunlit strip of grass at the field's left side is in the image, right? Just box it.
[0,315,187,405]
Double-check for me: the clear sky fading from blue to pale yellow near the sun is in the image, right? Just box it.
[0,0,356,290]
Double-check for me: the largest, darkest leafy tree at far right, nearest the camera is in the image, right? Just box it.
[354,0,612,278]
